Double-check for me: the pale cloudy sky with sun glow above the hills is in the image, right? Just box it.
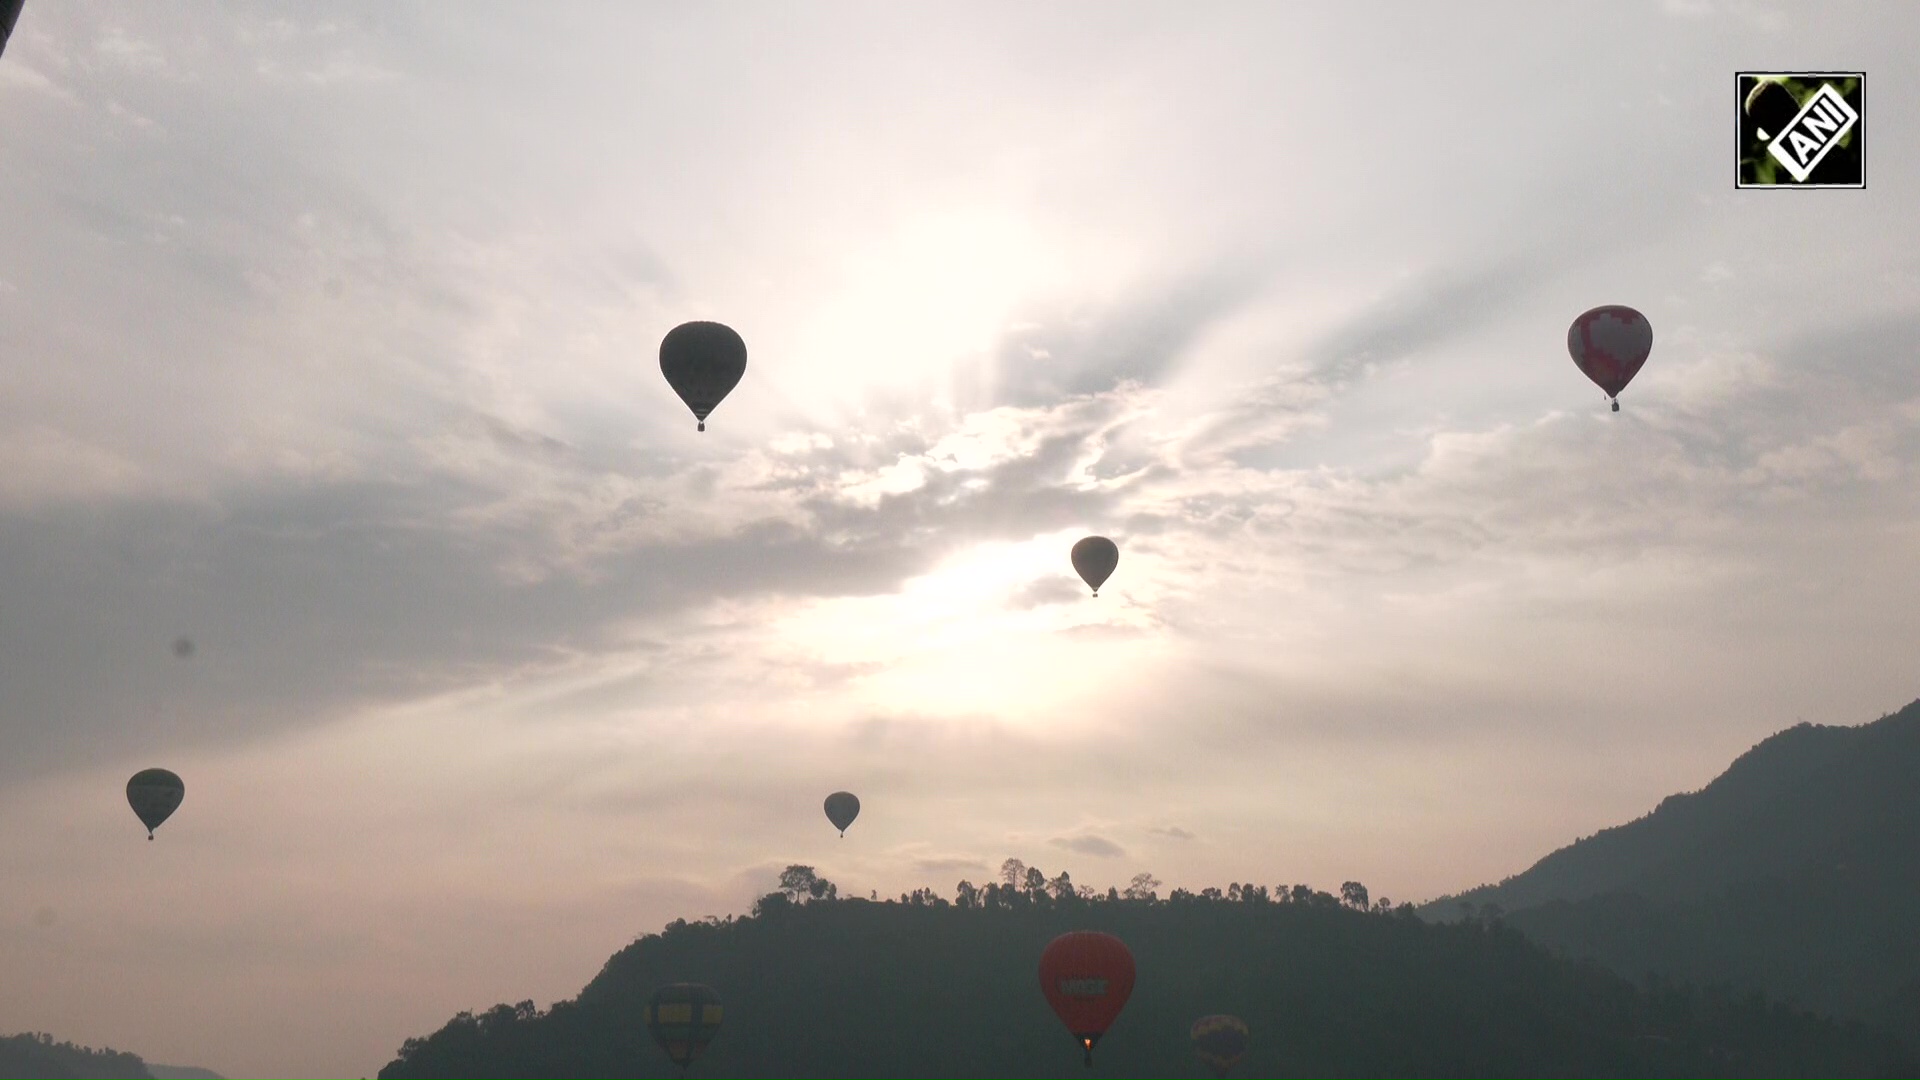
[0,0,1920,1080]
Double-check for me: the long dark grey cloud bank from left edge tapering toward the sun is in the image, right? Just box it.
[0,374,1152,776]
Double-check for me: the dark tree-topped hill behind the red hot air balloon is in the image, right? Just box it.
[380,886,1920,1080]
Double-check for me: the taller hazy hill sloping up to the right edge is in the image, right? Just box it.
[1421,701,1920,1047]
